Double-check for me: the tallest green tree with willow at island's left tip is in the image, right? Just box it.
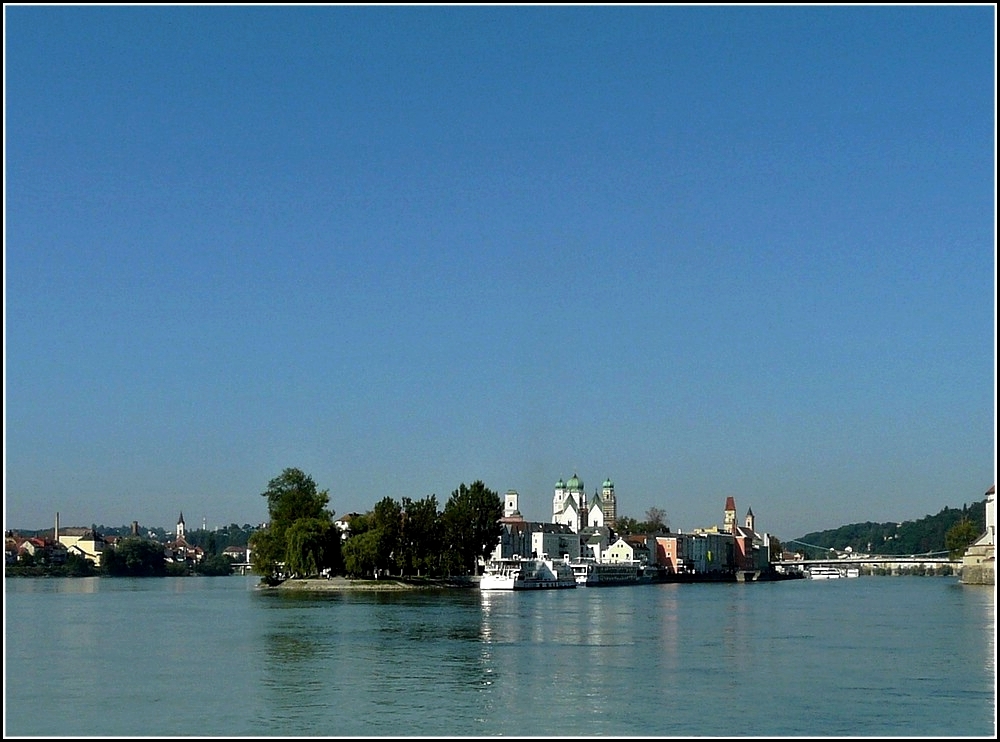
[250,468,340,581]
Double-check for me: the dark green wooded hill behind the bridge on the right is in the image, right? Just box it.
[785,499,986,559]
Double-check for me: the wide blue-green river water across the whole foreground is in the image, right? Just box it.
[4,576,997,738]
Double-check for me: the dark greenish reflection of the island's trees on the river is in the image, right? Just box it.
[252,590,498,736]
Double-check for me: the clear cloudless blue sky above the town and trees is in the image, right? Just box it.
[4,4,997,539]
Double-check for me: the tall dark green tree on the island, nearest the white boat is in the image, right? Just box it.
[441,480,503,574]
